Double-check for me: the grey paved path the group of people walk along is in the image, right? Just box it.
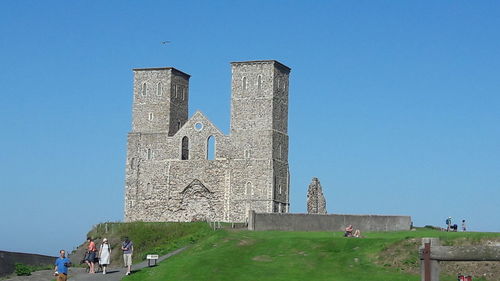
[5,247,188,281]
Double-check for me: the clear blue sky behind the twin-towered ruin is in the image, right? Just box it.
[0,0,500,255]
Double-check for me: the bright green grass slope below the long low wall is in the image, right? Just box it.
[123,230,500,281]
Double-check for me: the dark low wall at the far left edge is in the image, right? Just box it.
[0,251,57,277]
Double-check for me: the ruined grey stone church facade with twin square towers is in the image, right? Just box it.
[125,60,290,222]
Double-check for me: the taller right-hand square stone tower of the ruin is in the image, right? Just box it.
[231,61,290,212]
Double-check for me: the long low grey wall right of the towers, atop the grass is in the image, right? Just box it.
[248,211,411,232]
